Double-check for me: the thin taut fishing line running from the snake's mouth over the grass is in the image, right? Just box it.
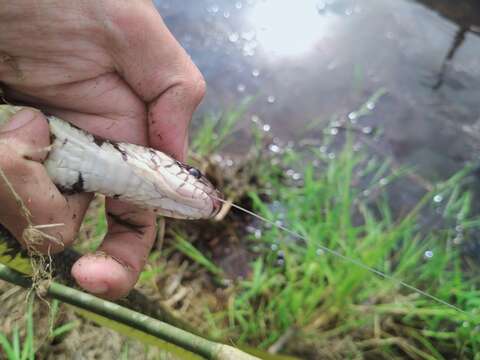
[210,195,469,315]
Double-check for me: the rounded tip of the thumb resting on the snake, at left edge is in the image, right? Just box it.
[0,108,50,162]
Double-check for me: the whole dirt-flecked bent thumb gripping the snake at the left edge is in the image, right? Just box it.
[0,109,89,252]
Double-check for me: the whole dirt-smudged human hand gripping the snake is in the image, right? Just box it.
[0,0,205,299]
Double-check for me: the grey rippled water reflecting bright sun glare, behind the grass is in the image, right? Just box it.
[157,0,480,262]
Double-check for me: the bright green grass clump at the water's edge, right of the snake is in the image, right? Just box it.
[211,134,480,359]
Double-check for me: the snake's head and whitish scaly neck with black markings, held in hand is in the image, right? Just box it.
[0,105,223,220]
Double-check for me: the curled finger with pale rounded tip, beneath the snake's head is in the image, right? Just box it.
[72,199,156,299]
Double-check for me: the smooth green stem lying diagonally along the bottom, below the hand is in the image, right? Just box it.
[0,264,257,360]
